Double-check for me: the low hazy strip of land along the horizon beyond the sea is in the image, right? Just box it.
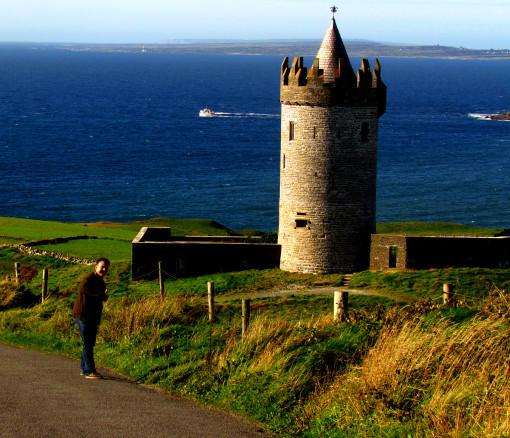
[0,40,510,60]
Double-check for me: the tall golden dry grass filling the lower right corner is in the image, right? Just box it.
[300,290,510,438]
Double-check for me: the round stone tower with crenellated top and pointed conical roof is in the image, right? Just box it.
[278,18,386,273]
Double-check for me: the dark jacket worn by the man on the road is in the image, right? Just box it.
[73,272,108,325]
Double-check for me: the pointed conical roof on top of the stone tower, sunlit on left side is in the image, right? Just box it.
[316,17,354,83]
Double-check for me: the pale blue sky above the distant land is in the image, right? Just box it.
[0,0,510,49]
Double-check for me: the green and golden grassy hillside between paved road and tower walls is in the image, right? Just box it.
[0,220,510,438]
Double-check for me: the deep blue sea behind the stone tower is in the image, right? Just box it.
[0,44,510,234]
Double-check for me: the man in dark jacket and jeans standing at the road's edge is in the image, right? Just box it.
[73,257,110,379]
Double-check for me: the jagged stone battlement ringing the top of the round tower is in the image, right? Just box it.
[280,57,386,117]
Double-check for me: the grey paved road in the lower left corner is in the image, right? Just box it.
[0,344,268,438]
